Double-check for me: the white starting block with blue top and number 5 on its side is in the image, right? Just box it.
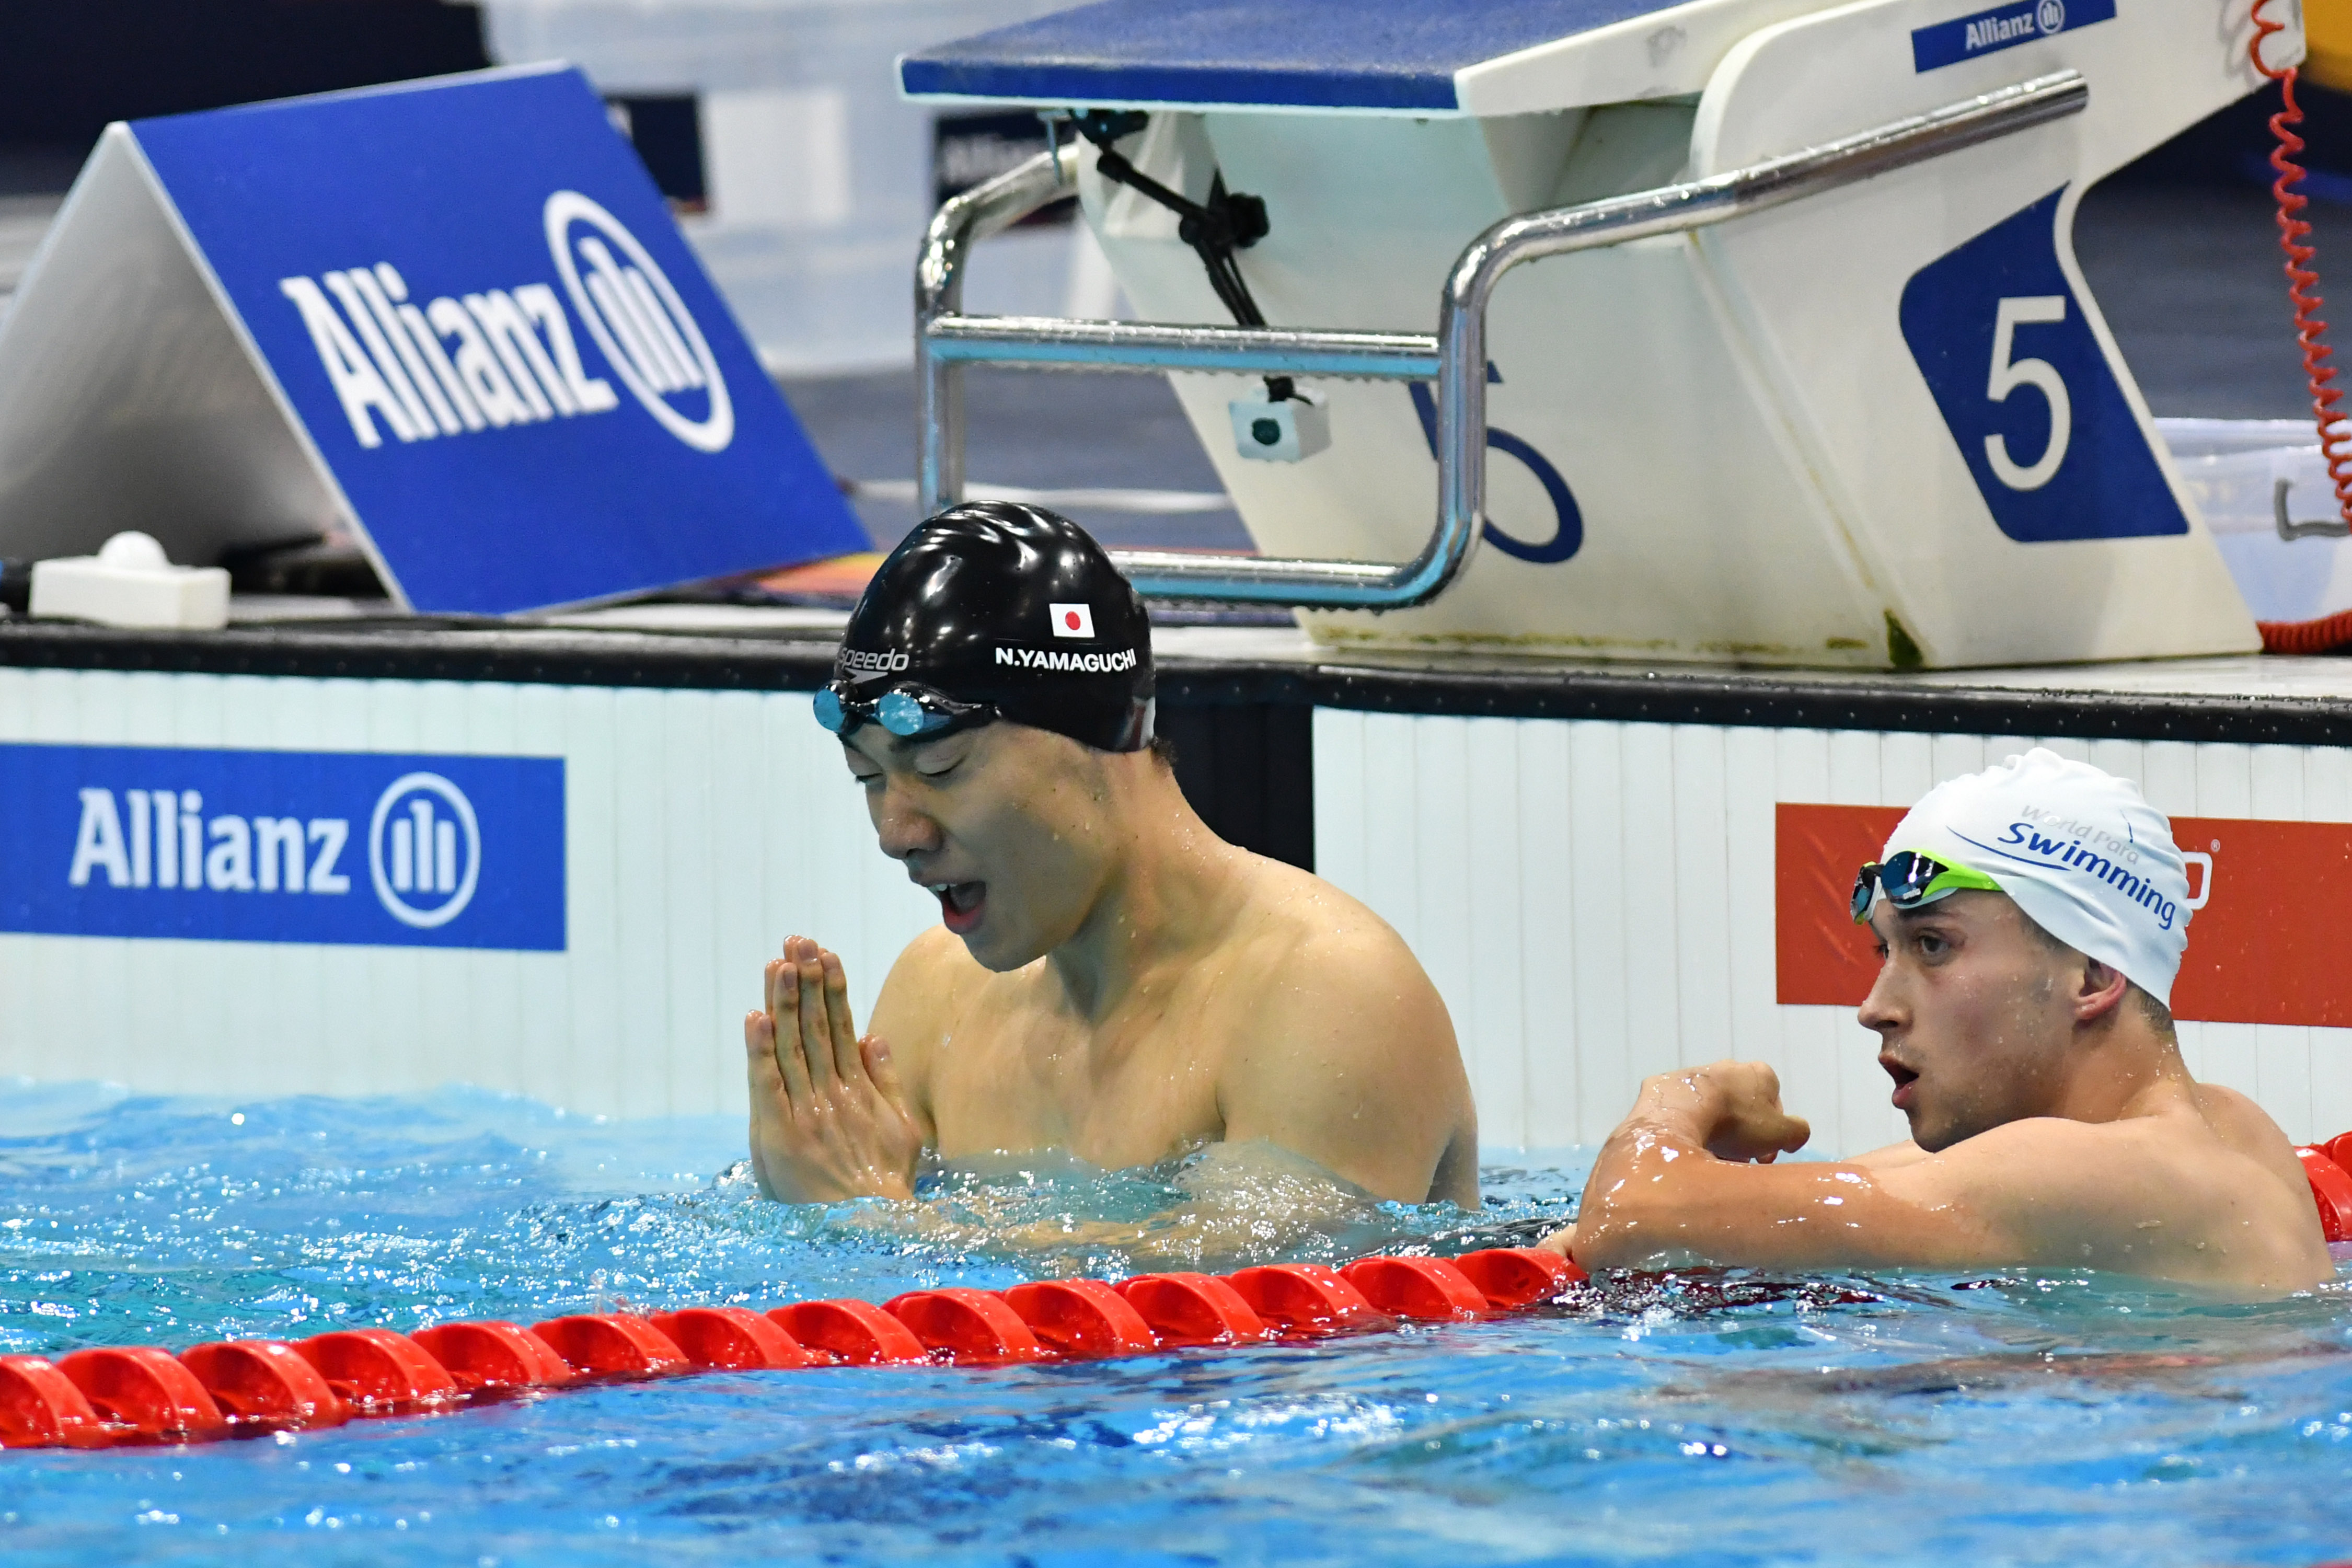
[901,0,2300,667]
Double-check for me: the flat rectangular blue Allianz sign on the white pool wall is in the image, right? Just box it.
[0,745,564,952]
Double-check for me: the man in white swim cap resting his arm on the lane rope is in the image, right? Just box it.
[1546,747,2333,1295]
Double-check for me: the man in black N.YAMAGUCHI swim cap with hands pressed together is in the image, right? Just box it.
[743,503,1477,1206]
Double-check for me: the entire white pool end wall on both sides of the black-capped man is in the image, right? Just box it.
[0,667,2352,1152]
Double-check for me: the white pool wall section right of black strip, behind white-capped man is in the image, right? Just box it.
[1315,708,2352,1154]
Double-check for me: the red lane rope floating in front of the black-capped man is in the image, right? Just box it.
[0,1250,1581,1448]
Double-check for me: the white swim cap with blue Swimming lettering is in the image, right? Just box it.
[1880,745,2190,1006]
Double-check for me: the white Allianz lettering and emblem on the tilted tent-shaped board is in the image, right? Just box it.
[278,190,734,452]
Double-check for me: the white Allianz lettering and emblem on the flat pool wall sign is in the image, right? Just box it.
[66,774,482,929]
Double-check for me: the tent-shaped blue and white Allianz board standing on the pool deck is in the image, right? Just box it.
[0,66,868,614]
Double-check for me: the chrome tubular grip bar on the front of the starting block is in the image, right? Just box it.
[915,71,2091,609]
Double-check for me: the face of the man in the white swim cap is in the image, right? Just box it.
[1861,891,2084,1154]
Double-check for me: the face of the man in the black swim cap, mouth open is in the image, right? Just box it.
[842,724,1129,973]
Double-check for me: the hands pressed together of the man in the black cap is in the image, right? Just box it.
[743,936,922,1204]
